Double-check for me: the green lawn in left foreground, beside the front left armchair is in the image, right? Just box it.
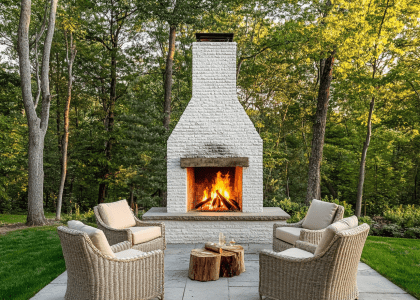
[0,226,66,300]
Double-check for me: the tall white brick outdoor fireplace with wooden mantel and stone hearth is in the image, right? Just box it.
[143,35,289,243]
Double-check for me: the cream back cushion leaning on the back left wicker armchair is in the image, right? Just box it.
[98,200,136,229]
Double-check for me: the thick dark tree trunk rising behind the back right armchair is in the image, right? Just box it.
[305,50,335,205]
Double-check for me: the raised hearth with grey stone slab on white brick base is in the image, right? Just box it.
[143,207,290,244]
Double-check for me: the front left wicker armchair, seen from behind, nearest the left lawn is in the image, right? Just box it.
[57,226,164,300]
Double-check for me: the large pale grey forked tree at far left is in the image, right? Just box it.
[18,0,58,225]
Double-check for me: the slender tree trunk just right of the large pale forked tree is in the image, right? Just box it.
[55,32,77,220]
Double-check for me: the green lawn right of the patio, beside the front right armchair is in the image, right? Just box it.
[361,236,420,299]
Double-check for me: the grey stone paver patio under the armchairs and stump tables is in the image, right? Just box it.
[32,244,416,300]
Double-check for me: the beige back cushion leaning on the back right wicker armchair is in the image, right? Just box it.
[302,199,338,230]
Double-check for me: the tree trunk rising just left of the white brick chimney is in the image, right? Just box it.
[163,25,176,130]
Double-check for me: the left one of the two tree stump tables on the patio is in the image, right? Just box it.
[188,249,221,281]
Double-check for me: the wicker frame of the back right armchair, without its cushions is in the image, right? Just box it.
[273,205,344,252]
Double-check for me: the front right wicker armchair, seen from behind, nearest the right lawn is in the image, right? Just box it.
[259,224,369,300]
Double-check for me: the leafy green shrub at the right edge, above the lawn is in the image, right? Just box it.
[384,204,420,228]
